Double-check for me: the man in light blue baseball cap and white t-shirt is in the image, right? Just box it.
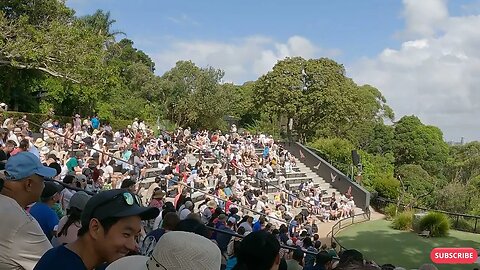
[0,152,56,269]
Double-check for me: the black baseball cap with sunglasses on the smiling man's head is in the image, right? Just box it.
[81,189,160,226]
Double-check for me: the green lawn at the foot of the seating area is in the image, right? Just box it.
[337,220,480,270]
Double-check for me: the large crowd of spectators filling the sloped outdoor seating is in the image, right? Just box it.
[0,115,454,270]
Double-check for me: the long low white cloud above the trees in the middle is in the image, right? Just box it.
[149,36,339,83]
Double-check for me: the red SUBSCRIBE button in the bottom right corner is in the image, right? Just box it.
[430,248,478,264]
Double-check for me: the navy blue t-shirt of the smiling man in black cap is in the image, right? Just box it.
[33,246,87,270]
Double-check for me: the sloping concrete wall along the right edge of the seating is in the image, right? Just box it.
[280,142,370,210]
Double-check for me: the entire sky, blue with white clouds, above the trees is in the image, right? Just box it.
[67,0,480,141]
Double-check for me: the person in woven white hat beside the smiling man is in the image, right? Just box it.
[107,231,221,270]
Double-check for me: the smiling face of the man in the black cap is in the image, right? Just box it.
[90,216,142,263]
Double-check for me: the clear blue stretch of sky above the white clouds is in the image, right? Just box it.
[67,0,403,65]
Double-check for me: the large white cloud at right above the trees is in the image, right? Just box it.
[347,0,480,140]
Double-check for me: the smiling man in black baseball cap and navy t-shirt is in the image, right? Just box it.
[35,189,160,270]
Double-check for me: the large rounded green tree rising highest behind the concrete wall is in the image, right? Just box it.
[254,57,393,142]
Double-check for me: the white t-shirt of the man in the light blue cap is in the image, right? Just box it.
[0,194,52,270]
